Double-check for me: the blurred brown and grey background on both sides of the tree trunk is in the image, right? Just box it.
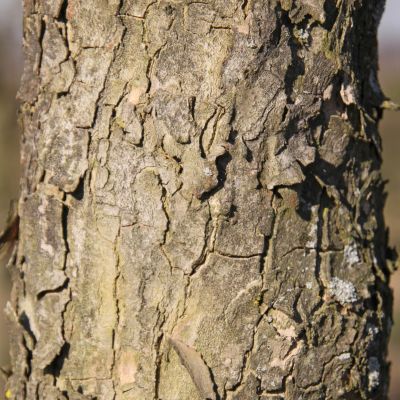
[0,0,400,400]
